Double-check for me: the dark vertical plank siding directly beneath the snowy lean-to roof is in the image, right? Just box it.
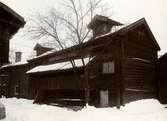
[29,75,85,90]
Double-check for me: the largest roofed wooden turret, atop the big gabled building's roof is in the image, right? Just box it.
[88,15,123,38]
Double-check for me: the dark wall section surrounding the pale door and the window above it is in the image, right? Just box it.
[88,52,117,107]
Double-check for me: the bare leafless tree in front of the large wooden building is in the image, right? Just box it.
[28,0,111,105]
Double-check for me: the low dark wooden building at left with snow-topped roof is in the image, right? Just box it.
[0,62,31,98]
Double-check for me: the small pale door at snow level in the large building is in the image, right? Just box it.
[100,90,109,107]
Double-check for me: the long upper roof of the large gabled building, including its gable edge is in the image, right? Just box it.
[29,18,160,61]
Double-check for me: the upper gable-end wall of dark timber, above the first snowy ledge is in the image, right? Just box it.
[124,30,157,61]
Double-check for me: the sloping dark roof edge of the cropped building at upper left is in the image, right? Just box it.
[0,2,25,23]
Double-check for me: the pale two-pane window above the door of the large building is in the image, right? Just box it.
[103,61,115,74]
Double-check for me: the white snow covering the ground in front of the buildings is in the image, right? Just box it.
[0,98,167,121]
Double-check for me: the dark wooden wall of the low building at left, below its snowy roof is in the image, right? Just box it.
[0,65,29,98]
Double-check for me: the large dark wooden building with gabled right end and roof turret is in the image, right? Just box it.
[27,15,160,107]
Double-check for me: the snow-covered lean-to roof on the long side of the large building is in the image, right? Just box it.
[27,58,92,73]
